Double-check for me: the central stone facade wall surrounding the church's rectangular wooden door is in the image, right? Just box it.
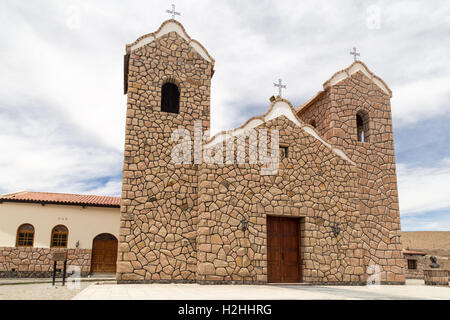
[197,116,365,284]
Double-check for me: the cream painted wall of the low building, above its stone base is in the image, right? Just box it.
[0,202,120,249]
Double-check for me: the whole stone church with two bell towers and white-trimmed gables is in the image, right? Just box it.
[117,20,405,284]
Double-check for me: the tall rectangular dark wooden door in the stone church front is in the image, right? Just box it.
[267,216,301,283]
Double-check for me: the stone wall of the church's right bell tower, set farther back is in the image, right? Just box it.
[299,62,405,284]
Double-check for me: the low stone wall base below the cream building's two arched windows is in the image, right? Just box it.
[0,247,91,278]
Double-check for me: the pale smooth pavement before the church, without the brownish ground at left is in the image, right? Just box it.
[73,280,450,300]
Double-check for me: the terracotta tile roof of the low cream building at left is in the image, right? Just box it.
[0,191,120,208]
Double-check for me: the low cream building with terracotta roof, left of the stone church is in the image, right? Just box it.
[0,191,120,278]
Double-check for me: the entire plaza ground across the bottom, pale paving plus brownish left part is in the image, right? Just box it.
[0,280,450,300]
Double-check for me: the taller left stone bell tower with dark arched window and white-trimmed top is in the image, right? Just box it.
[117,19,214,282]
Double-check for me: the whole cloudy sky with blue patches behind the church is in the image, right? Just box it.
[0,0,450,230]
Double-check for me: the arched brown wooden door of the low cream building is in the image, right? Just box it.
[91,233,117,273]
